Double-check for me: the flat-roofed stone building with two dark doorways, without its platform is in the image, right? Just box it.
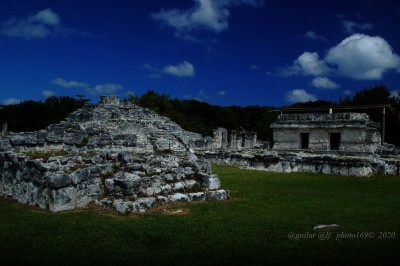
[271,113,381,153]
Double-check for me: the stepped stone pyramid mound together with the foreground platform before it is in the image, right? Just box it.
[0,96,229,214]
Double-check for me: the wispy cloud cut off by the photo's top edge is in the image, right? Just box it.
[150,0,263,35]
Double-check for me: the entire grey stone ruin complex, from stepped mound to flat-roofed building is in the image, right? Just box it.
[0,96,400,214]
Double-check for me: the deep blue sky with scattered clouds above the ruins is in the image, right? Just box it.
[0,0,400,106]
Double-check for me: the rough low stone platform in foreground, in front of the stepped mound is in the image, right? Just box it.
[0,152,229,214]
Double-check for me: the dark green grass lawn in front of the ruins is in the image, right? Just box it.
[0,165,400,265]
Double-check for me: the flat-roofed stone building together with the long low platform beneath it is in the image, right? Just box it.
[197,113,400,176]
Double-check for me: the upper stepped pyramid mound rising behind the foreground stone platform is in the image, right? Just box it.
[0,96,206,153]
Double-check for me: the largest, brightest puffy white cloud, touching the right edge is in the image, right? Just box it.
[325,34,400,80]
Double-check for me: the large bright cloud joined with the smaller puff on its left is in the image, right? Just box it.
[276,33,400,80]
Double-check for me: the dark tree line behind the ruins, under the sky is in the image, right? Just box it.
[0,85,400,146]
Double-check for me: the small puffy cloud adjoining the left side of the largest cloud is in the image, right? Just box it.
[277,52,330,77]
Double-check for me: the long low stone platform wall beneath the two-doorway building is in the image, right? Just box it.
[197,152,400,176]
